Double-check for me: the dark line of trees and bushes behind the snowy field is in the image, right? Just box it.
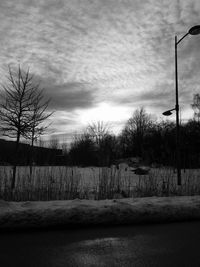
[68,101,200,168]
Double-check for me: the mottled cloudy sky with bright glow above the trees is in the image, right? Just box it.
[0,0,200,142]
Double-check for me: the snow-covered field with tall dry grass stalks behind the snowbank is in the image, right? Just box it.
[0,166,200,201]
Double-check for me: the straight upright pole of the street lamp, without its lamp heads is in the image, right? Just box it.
[175,36,181,185]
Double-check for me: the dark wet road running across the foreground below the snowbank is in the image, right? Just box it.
[0,222,200,267]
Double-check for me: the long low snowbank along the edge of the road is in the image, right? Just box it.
[0,196,200,230]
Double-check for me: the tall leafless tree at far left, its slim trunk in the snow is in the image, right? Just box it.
[0,66,37,189]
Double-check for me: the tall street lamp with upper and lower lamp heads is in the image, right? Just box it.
[163,25,200,185]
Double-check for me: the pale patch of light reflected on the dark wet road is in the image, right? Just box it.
[57,238,158,266]
